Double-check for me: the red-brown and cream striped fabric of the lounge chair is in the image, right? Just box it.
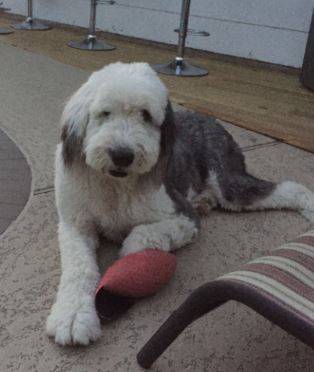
[219,230,314,323]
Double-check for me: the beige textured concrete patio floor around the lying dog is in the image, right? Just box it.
[0,40,314,372]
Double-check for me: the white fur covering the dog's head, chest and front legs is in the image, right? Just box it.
[47,63,197,345]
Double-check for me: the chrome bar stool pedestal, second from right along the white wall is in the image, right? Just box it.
[68,0,116,51]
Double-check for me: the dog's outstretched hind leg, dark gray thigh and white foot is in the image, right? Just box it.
[209,174,314,222]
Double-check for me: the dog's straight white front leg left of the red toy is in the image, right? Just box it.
[47,222,100,345]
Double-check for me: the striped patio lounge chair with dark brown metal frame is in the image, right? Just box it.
[137,230,314,368]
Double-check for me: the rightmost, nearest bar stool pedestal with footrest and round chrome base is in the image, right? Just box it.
[152,0,209,76]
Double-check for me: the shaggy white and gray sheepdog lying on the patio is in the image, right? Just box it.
[47,63,314,345]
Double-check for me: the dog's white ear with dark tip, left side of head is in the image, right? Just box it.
[61,80,93,166]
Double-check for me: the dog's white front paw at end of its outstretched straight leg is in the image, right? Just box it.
[46,303,101,345]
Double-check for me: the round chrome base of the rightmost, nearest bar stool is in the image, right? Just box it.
[152,58,208,76]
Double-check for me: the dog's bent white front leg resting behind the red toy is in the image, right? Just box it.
[121,214,198,256]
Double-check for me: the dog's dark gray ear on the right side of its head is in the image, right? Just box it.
[160,100,176,156]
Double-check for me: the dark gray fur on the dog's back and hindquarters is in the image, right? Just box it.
[165,112,275,215]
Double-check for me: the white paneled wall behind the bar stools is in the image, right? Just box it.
[3,0,314,67]
